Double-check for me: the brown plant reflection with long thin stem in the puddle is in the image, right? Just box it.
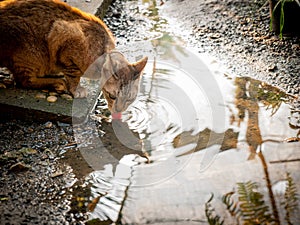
[173,77,297,223]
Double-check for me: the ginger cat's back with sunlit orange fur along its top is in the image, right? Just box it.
[0,0,114,60]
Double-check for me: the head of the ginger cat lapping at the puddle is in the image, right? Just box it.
[101,51,148,113]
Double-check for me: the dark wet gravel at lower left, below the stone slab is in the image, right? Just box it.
[0,120,78,224]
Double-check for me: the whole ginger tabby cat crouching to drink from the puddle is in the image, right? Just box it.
[0,0,147,112]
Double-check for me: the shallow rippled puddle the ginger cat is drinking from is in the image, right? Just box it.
[68,1,300,224]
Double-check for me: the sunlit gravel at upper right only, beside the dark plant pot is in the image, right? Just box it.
[163,0,300,95]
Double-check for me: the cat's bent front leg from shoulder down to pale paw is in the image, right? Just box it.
[47,20,90,98]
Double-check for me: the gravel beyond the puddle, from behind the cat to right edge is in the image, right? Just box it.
[105,0,300,95]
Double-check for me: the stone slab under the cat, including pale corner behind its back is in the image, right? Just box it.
[0,0,111,123]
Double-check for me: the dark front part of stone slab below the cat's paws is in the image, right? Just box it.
[0,85,94,123]
